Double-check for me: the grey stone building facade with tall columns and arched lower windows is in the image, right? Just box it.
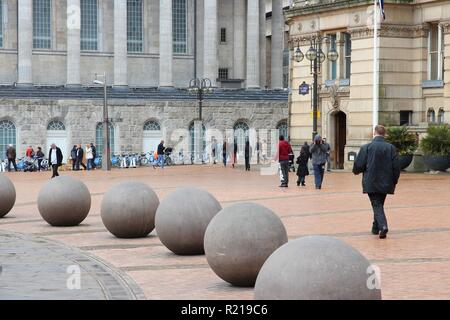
[0,0,290,159]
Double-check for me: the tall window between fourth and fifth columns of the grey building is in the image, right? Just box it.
[172,0,187,53]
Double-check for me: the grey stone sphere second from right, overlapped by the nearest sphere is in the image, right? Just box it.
[205,203,288,287]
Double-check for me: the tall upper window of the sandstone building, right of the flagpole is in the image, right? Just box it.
[428,24,444,80]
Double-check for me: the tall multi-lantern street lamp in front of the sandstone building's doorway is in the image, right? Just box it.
[290,35,339,140]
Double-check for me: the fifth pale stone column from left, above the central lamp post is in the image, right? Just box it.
[203,0,219,87]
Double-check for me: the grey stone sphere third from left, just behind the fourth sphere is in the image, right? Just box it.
[101,181,159,238]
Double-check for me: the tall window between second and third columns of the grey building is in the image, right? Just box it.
[80,0,98,51]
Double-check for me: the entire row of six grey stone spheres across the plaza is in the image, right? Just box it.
[0,174,381,300]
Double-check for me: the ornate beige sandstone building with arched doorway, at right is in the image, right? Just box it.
[285,0,450,168]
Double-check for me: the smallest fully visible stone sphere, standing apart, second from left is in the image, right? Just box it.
[38,176,91,227]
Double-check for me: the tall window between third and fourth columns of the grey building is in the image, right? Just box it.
[127,0,144,52]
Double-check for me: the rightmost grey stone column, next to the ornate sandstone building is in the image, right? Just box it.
[271,0,284,89]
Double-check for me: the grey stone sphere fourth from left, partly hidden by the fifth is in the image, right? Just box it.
[155,187,222,255]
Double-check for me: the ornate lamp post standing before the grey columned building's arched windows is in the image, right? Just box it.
[188,78,213,163]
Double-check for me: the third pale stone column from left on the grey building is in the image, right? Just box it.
[114,0,128,88]
